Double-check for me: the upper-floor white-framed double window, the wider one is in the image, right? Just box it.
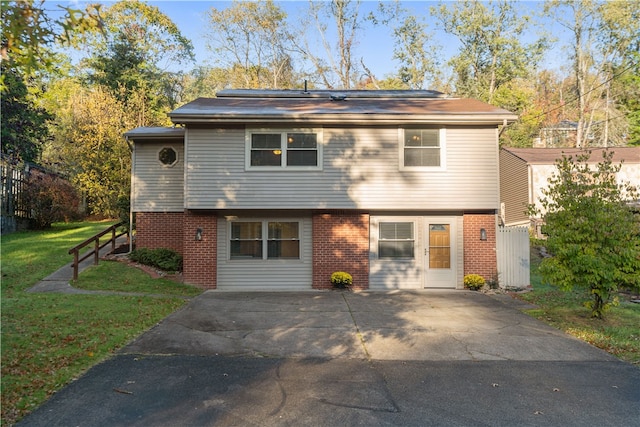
[246,129,322,170]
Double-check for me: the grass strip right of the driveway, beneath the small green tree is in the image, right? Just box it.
[518,251,640,366]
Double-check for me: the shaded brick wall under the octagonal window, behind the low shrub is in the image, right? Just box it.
[136,212,184,254]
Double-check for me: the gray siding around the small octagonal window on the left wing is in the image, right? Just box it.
[131,142,184,212]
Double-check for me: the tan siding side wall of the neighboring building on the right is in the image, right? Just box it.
[500,150,530,225]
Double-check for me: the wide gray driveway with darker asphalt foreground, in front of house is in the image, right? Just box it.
[21,291,640,426]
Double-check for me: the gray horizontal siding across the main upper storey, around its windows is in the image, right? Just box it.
[185,127,499,210]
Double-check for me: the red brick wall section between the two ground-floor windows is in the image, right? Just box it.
[312,213,369,289]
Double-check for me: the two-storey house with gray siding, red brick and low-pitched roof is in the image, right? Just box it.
[126,90,516,290]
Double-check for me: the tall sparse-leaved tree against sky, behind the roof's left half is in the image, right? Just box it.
[208,0,293,89]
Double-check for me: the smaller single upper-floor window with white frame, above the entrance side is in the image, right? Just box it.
[400,129,445,169]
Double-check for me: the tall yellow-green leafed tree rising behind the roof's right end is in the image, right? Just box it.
[431,0,547,103]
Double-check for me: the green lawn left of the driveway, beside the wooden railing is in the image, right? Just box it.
[1,222,200,425]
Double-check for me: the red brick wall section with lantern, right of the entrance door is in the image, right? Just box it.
[463,214,498,280]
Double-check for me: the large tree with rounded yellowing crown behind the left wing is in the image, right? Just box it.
[81,1,194,126]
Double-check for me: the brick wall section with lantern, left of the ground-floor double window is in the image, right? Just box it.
[182,211,218,289]
